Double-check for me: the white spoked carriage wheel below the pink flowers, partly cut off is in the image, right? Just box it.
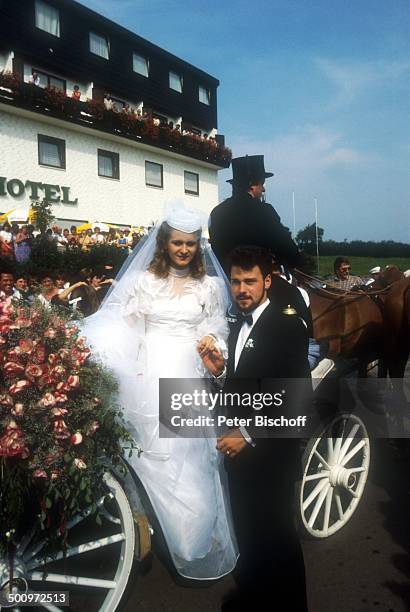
[0,473,136,612]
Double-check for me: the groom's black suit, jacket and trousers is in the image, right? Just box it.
[224,289,311,612]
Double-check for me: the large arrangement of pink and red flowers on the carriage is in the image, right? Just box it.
[0,300,139,605]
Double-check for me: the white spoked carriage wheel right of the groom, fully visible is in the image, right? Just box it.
[298,414,370,538]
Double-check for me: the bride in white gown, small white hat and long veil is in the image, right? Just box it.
[84,206,237,579]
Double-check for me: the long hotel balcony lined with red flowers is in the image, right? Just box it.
[0,72,232,168]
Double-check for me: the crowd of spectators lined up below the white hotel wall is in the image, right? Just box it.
[0,222,147,263]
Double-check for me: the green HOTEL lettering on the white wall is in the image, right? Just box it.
[0,176,78,205]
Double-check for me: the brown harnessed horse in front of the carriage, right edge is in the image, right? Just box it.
[296,267,410,378]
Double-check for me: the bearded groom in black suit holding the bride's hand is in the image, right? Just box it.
[205,247,310,612]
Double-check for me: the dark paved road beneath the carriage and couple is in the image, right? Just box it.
[126,440,410,612]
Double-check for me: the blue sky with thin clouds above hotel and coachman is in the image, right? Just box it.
[78,0,410,242]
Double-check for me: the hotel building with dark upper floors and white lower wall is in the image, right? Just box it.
[0,0,229,227]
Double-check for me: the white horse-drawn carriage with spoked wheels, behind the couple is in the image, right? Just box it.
[0,268,406,612]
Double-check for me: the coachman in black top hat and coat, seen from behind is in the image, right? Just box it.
[209,155,301,270]
